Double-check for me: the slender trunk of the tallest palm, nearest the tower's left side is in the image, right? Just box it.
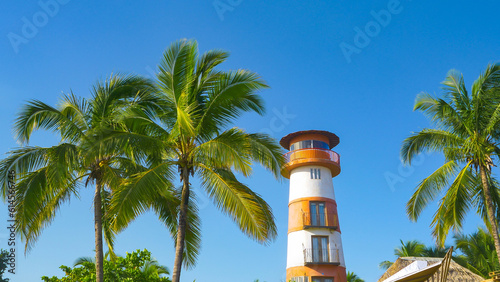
[172,168,189,282]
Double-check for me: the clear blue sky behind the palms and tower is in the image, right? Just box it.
[0,0,500,282]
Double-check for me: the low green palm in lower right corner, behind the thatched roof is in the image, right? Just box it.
[455,228,500,278]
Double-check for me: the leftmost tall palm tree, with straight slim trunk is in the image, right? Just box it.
[0,75,158,282]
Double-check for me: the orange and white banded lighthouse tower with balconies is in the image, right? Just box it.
[280,130,347,282]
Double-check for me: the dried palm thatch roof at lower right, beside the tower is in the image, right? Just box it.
[378,257,484,282]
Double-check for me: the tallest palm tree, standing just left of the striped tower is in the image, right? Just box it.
[113,40,284,282]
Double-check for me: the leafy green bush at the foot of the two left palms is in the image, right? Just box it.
[42,250,170,282]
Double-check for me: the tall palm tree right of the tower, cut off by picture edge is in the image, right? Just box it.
[401,64,500,259]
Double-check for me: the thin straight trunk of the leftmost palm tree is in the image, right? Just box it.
[94,180,104,282]
